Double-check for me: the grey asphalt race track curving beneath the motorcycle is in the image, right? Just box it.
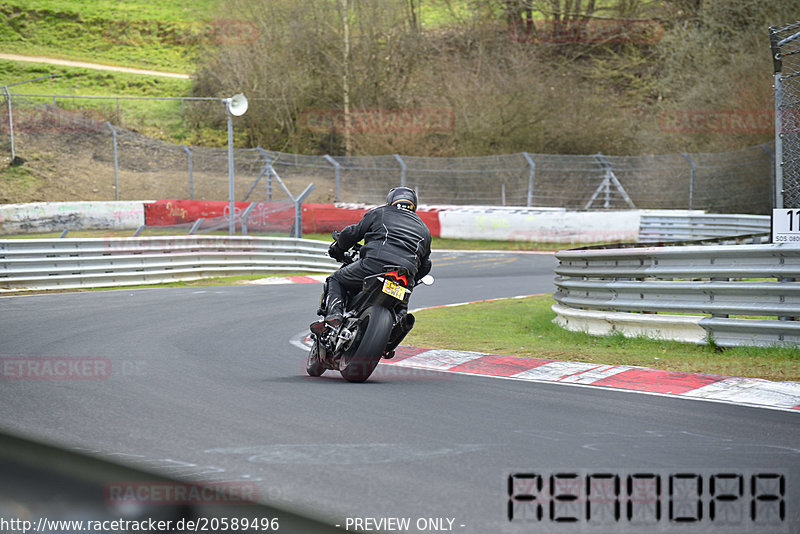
[0,252,800,534]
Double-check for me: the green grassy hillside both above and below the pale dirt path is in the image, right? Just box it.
[0,0,220,146]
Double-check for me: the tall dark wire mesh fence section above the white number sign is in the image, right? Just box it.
[770,21,800,208]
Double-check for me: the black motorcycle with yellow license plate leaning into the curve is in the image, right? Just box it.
[306,232,433,382]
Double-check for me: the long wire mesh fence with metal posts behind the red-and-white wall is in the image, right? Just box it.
[0,95,774,214]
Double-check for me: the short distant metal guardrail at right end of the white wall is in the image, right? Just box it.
[639,212,771,243]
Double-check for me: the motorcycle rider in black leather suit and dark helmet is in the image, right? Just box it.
[317,187,431,335]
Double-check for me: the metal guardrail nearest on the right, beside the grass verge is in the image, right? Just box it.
[553,245,800,346]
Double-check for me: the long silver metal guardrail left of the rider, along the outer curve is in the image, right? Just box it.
[0,236,339,291]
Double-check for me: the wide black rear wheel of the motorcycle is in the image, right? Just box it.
[339,306,392,382]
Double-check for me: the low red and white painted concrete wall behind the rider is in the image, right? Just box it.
[0,199,642,243]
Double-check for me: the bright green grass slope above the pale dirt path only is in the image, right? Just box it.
[0,0,218,73]
